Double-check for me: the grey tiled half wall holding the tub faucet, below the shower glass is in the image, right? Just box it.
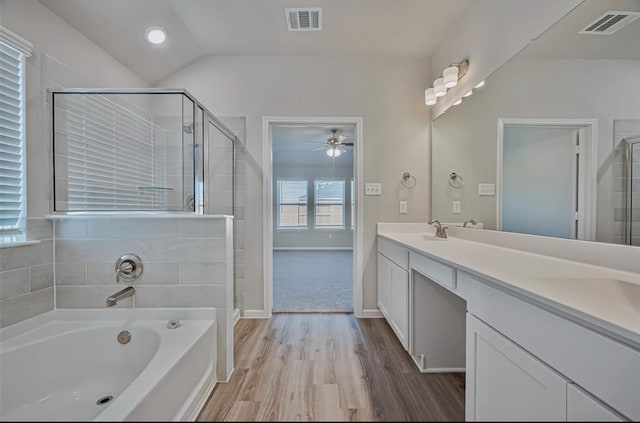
[52,214,233,381]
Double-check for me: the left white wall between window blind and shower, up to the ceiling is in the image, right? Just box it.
[0,0,147,217]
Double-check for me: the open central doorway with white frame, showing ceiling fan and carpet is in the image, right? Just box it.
[264,118,362,316]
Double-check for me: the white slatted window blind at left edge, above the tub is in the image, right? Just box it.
[0,42,25,234]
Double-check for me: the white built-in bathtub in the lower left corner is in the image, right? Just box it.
[0,308,216,421]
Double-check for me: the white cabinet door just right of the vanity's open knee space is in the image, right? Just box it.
[466,314,567,421]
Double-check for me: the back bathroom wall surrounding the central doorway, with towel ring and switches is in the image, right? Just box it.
[158,57,431,310]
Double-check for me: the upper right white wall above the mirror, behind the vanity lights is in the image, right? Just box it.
[428,0,583,118]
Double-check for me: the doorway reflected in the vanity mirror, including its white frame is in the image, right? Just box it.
[496,119,596,240]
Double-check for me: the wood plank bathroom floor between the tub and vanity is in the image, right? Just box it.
[198,314,464,421]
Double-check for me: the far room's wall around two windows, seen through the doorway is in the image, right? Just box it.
[273,165,353,249]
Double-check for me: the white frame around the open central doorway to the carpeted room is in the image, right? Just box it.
[262,116,364,317]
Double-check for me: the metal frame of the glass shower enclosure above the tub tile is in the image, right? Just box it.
[47,88,240,215]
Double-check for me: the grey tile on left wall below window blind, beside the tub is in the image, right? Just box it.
[0,219,54,327]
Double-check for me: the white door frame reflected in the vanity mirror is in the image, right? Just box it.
[496,118,598,241]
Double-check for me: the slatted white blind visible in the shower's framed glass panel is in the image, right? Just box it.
[54,94,173,210]
